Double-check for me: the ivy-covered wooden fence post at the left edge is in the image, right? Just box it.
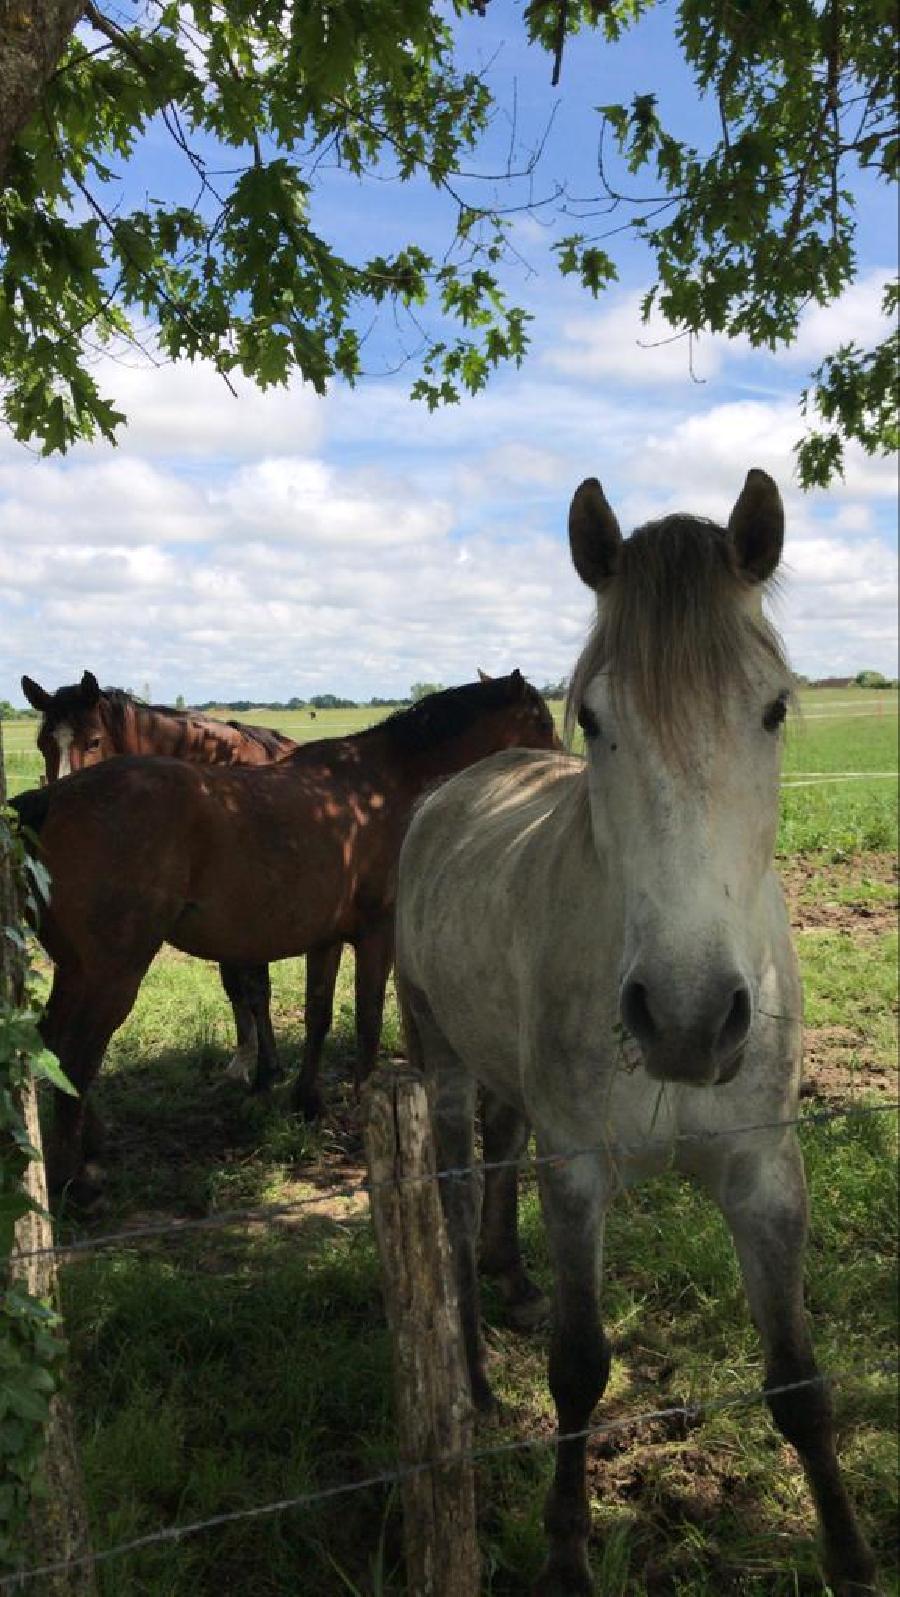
[0,727,97,1597]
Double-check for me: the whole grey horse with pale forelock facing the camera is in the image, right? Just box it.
[396,471,873,1597]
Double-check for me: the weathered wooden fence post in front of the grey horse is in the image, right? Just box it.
[365,1068,479,1597]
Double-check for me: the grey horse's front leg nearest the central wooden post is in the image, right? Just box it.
[535,1159,610,1597]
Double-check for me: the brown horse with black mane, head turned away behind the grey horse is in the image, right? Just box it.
[13,671,557,1185]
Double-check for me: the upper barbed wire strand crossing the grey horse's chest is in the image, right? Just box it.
[13,1098,900,1262]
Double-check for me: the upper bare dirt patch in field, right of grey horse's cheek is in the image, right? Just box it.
[779,854,898,933]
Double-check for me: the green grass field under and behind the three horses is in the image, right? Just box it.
[3,690,897,1597]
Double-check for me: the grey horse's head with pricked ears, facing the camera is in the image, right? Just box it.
[566,471,791,1086]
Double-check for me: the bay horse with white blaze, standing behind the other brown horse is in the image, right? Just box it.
[22,671,297,1088]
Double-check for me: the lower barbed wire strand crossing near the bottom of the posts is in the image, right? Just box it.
[0,1359,897,1592]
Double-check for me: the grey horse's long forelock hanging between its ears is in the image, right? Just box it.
[565,516,791,760]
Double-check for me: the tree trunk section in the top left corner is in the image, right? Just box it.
[0,0,85,188]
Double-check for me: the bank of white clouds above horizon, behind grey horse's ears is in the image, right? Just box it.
[0,325,895,703]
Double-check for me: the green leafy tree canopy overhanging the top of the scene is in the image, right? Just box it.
[0,0,898,485]
